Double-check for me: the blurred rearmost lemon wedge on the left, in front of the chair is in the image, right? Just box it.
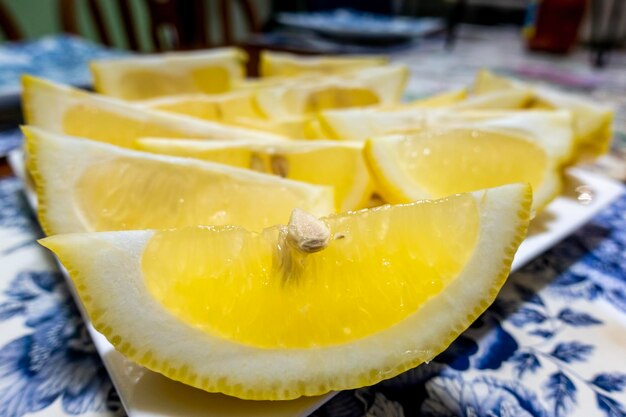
[90,48,248,100]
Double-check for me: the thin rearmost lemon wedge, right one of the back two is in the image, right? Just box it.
[259,51,387,77]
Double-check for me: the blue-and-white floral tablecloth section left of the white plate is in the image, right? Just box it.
[0,178,124,417]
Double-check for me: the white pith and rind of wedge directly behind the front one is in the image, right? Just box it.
[22,126,335,235]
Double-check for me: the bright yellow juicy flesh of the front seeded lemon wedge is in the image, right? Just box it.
[141,195,480,348]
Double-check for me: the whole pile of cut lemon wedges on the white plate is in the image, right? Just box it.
[23,48,611,400]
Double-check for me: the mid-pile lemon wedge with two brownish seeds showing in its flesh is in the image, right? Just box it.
[137,138,372,211]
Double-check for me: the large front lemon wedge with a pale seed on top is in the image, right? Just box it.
[40,184,531,400]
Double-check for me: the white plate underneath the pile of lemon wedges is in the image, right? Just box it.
[9,151,624,417]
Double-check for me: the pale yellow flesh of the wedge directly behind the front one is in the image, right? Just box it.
[73,157,326,231]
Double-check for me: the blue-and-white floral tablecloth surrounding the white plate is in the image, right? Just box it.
[0,27,626,417]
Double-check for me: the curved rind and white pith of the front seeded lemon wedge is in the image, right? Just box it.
[41,184,532,400]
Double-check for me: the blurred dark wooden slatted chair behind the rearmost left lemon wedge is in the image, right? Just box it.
[59,0,260,52]
